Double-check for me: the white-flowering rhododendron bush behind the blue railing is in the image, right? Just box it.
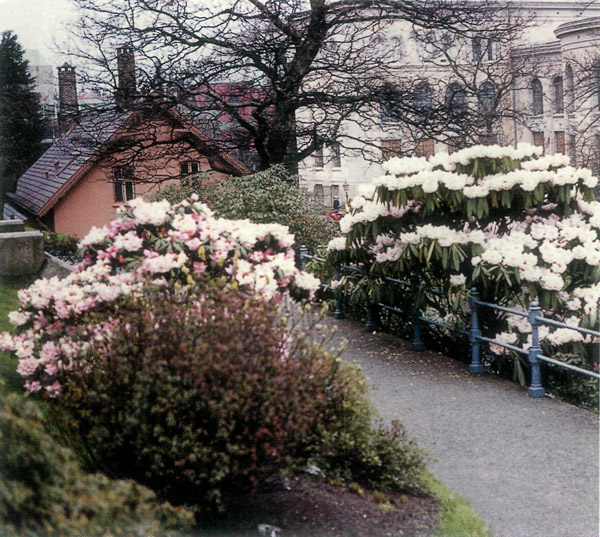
[318,145,600,404]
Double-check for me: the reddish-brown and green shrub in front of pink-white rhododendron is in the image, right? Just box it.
[53,286,423,512]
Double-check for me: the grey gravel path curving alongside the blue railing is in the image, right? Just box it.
[326,318,600,537]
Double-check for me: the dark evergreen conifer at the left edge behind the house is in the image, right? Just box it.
[0,31,44,217]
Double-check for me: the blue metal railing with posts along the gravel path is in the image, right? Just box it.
[300,246,600,398]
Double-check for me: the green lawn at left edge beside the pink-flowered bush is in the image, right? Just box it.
[0,276,35,394]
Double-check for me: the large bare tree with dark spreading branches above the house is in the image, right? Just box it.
[68,0,522,170]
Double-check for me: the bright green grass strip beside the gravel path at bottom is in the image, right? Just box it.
[427,474,492,537]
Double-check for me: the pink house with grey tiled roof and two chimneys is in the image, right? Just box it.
[9,49,250,237]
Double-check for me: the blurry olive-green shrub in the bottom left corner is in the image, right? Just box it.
[0,395,193,537]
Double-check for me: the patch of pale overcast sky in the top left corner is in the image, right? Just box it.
[0,0,75,65]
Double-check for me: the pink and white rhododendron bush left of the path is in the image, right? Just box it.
[0,197,318,396]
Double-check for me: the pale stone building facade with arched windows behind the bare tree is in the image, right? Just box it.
[300,0,600,206]
